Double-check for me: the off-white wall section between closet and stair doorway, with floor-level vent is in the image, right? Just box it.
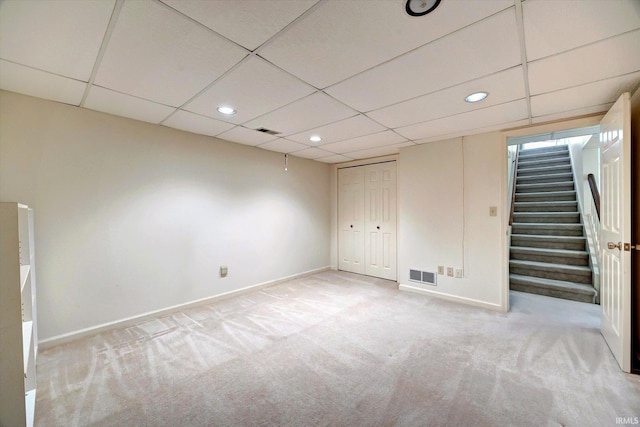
[398,132,508,310]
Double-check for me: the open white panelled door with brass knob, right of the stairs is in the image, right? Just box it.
[600,93,631,372]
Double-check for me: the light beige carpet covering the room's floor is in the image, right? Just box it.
[36,271,640,427]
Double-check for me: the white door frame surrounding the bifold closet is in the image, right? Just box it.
[330,154,400,283]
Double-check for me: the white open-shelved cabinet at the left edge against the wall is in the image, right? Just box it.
[0,202,38,427]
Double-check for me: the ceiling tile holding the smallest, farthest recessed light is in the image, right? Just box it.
[287,114,385,144]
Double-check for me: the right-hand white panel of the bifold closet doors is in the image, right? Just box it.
[364,162,396,280]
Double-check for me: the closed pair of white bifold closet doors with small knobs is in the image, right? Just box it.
[338,162,396,280]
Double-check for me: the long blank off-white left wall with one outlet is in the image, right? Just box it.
[0,92,331,340]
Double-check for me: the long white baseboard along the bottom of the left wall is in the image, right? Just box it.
[38,266,331,350]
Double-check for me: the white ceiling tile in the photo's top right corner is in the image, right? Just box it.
[522,0,640,61]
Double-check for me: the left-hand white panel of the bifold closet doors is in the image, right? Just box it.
[338,167,365,274]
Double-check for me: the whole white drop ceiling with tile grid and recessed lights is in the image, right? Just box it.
[0,0,640,163]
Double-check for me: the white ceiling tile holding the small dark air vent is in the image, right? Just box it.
[245,92,357,136]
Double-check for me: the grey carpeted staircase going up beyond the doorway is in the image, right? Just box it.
[509,145,597,303]
